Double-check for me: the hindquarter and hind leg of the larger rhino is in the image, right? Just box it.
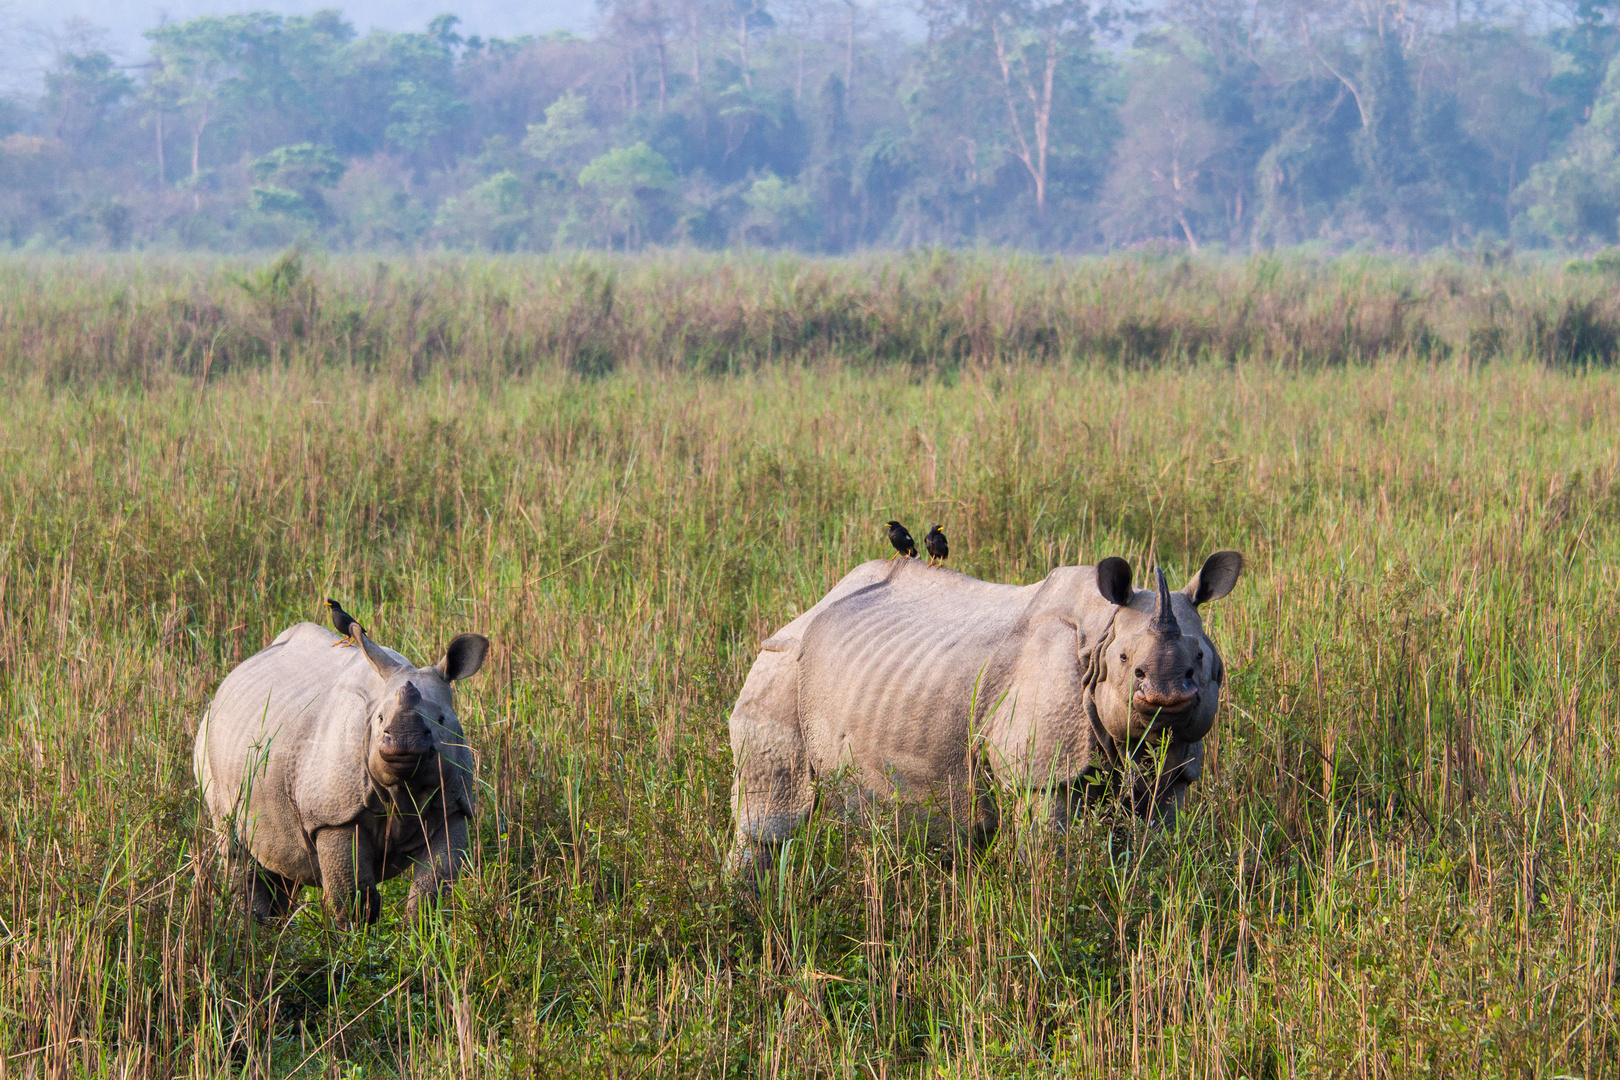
[726,643,815,874]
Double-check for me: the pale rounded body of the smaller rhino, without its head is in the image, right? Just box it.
[196,623,376,881]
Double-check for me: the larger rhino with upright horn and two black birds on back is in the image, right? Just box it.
[727,551,1243,871]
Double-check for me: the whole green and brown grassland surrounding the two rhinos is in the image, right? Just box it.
[0,253,1620,1080]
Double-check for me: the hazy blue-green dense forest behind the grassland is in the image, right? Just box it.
[9,0,1620,253]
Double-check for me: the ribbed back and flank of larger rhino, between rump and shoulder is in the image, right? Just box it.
[799,560,1040,790]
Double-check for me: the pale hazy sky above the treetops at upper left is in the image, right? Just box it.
[0,0,596,86]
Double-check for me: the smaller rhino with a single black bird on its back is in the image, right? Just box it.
[193,622,489,923]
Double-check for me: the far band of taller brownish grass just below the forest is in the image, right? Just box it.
[9,251,1620,384]
